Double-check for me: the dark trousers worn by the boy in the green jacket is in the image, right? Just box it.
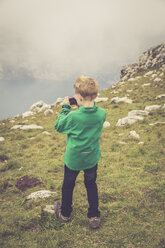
[61,164,100,218]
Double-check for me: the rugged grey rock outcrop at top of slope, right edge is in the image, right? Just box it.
[120,43,165,81]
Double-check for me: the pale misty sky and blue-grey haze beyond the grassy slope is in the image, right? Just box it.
[0,0,165,119]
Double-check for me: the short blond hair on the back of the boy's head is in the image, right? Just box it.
[74,76,99,100]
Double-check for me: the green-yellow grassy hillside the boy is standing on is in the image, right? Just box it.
[0,67,165,248]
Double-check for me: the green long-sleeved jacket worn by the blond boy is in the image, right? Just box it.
[54,102,106,170]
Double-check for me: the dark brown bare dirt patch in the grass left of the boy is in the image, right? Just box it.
[16,176,44,191]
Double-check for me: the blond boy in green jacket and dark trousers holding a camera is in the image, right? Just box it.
[55,76,106,228]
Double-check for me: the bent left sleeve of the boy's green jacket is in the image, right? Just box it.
[54,105,72,134]
